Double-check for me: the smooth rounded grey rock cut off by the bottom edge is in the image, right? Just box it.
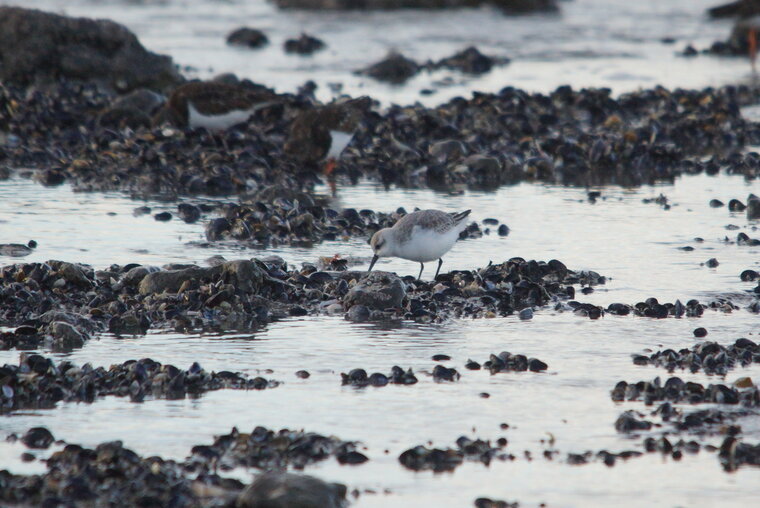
[235,472,346,508]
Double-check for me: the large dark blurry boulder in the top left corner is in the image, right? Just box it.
[0,7,183,92]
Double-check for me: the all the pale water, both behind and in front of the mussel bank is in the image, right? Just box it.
[0,0,760,507]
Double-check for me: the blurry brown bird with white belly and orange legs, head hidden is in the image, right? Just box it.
[284,97,371,191]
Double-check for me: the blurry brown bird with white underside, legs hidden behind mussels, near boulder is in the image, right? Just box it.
[153,81,275,132]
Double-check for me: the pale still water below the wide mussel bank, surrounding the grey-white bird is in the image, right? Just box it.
[0,175,760,506]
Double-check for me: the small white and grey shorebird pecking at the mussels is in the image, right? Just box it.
[367,210,470,279]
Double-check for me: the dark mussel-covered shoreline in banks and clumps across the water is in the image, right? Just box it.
[0,0,760,508]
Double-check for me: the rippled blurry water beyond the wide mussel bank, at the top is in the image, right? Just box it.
[0,0,750,105]
